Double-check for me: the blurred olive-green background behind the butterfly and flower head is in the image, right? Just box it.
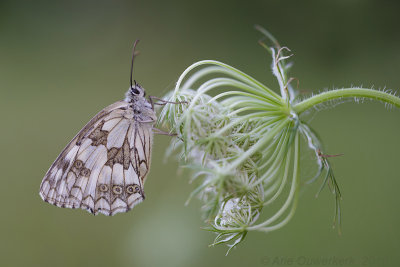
[0,0,400,267]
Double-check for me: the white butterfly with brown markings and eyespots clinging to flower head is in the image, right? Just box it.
[40,40,167,215]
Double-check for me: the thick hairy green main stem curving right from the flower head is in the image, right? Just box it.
[293,88,400,115]
